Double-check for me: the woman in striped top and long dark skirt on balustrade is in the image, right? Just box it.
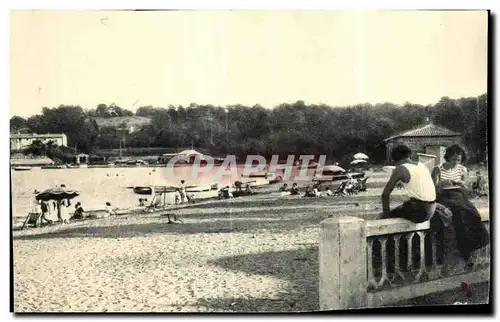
[432,145,489,266]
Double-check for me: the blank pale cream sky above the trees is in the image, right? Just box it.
[10,11,488,117]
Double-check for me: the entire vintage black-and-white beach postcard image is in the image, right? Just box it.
[10,10,491,313]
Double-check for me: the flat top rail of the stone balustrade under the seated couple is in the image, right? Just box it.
[366,207,490,237]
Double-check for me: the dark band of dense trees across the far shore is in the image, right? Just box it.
[10,94,488,163]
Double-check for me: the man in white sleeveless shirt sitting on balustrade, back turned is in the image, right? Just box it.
[381,145,436,223]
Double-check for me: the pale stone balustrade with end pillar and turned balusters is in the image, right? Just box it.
[319,208,490,310]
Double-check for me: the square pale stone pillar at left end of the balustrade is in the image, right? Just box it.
[319,217,368,310]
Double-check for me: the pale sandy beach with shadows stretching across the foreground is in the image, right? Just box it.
[13,174,487,312]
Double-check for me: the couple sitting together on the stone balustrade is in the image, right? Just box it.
[380,145,489,267]
